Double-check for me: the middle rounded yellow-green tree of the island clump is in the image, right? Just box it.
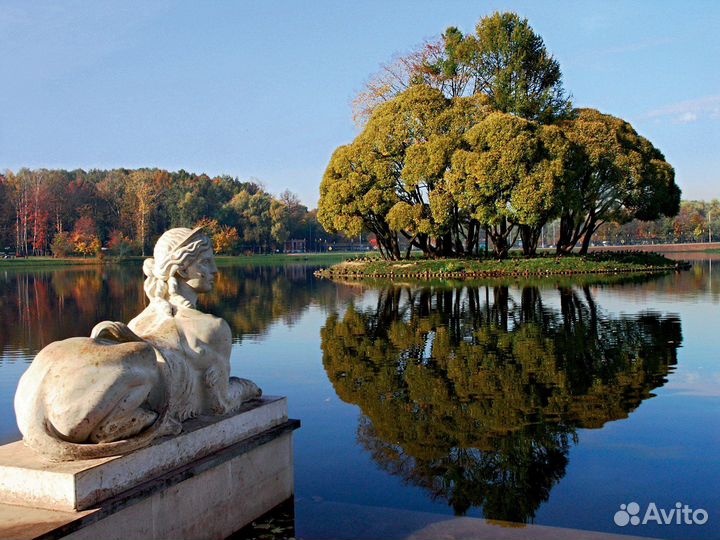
[438,112,572,258]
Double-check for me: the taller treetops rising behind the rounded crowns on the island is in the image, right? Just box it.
[353,12,571,123]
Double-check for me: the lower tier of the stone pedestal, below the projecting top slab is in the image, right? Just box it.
[0,420,299,540]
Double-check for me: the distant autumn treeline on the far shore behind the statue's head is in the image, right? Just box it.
[0,169,342,256]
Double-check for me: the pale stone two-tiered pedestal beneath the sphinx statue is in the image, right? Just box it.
[0,397,299,540]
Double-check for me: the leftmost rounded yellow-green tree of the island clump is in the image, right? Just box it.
[318,84,488,259]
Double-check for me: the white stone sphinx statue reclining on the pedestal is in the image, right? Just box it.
[15,228,261,461]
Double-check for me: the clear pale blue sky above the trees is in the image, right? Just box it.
[0,0,720,207]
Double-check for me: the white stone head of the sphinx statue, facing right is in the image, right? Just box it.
[143,227,217,314]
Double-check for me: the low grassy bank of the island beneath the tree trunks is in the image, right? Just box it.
[315,252,690,279]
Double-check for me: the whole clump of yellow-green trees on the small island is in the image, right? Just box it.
[318,13,680,259]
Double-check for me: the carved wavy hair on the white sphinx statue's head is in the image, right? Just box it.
[143,234,212,316]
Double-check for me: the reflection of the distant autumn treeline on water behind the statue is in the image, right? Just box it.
[0,265,348,361]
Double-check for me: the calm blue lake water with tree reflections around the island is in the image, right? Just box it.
[0,254,720,538]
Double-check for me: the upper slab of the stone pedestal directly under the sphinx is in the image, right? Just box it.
[0,397,287,510]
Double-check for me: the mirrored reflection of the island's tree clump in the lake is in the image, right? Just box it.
[322,287,682,522]
